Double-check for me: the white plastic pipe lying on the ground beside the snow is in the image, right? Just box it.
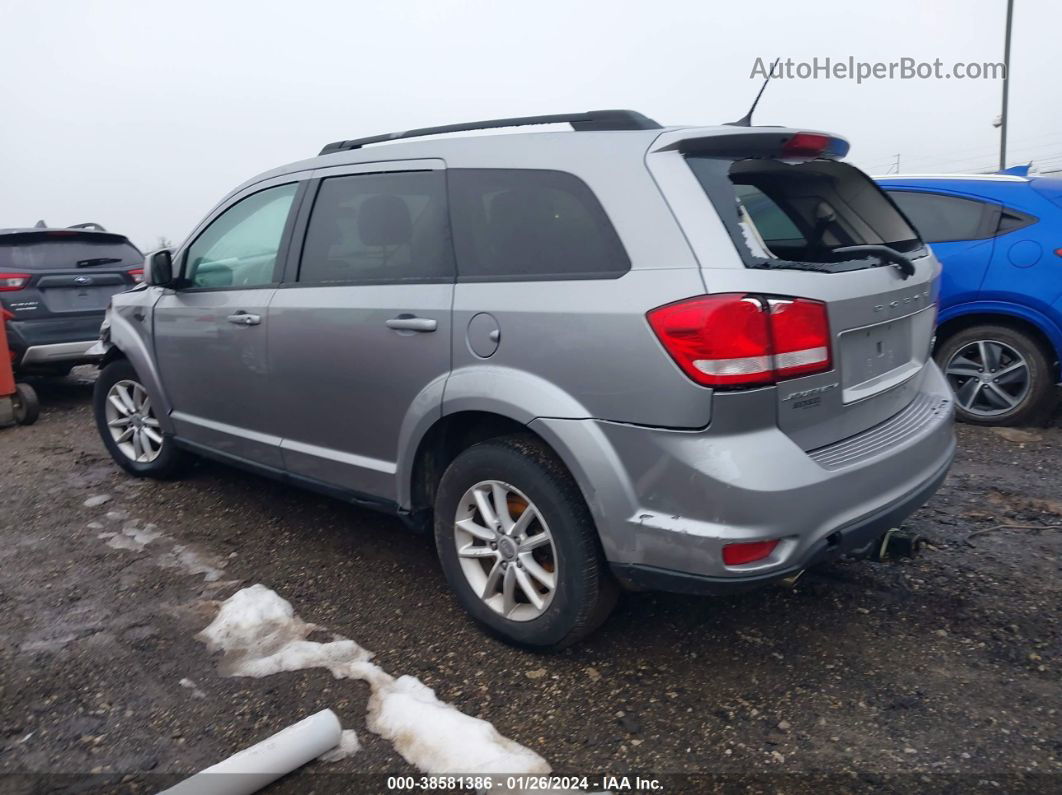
[161,709,343,795]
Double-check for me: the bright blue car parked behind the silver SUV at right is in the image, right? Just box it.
[877,173,1062,426]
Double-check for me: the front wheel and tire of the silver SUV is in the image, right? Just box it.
[92,359,189,479]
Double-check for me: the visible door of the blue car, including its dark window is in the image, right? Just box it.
[886,188,1000,309]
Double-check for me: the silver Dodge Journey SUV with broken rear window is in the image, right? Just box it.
[95,110,955,649]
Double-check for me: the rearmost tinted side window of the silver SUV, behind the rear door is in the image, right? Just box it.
[447,169,631,281]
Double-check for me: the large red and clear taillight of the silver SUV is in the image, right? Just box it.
[647,293,833,388]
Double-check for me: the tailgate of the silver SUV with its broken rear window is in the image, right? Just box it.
[662,131,940,450]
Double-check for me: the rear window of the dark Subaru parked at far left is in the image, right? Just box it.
[0,229,143,271]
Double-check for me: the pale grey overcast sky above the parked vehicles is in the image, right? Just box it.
[0,0,1062,248]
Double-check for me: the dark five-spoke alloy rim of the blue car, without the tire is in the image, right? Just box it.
[944,340,1029,417]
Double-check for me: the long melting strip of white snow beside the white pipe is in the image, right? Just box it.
[196,584,551,774]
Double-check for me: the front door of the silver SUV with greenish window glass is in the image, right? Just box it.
[149,183,298,469]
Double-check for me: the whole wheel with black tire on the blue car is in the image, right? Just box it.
[935,325,1056,426]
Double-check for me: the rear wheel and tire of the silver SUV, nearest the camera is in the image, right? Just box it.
[435,435,618,651]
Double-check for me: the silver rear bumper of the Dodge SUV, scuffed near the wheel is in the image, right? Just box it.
[531,363,955,592]
